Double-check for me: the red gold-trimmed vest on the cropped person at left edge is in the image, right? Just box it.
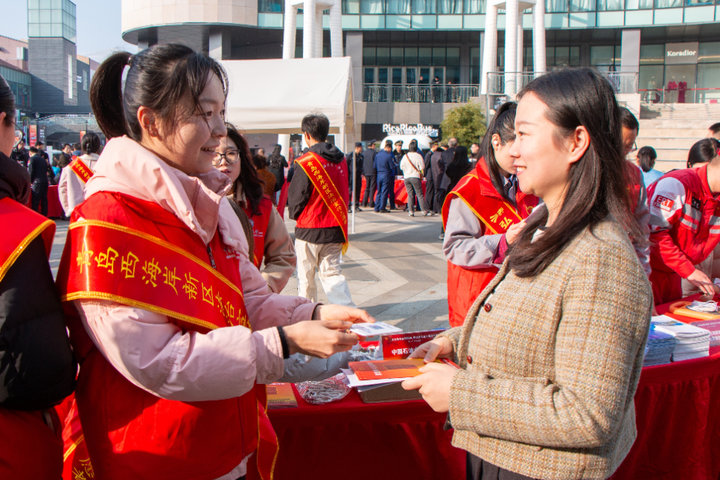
[0,197,62,479]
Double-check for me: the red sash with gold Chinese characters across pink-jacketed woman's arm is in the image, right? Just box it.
[58,220,249,331]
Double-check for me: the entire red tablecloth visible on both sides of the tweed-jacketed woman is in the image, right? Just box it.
[270,296,720,480]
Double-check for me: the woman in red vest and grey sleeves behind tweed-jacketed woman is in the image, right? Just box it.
[442,102,538,327]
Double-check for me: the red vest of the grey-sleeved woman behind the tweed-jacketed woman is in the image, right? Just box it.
[442,163,538,327]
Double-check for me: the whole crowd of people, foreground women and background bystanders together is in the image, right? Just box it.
[0,44,720,480]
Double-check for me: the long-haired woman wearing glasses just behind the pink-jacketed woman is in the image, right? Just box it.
[213,124,297,293]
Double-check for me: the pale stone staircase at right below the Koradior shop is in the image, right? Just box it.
[631,103,720,172]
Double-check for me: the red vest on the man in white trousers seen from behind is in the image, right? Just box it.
[296,152,349,253]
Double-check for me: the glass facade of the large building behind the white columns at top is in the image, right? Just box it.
[258,0,720,102]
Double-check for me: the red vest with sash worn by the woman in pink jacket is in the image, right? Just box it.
[57,192,277,480]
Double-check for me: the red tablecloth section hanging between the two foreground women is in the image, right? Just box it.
[269,390,465,480]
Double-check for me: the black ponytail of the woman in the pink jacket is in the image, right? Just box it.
[90,52,132,140]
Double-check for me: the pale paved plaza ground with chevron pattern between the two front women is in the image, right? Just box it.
[50,208,448,331]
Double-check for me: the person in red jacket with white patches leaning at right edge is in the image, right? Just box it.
[648,139,720,305]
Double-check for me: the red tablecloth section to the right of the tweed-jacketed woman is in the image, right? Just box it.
[612,296,720,480]
